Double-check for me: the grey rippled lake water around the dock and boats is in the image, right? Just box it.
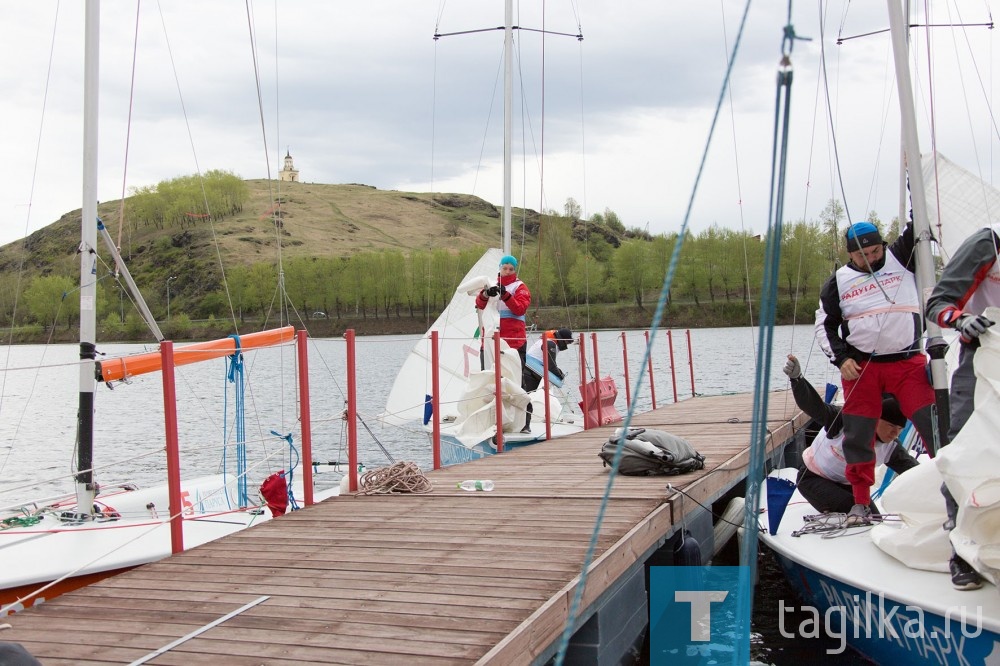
[0,326,864,666]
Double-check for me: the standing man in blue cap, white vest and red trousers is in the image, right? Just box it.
[816,222,947,526]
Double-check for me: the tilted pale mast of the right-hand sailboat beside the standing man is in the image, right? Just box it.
[886,0,948,451]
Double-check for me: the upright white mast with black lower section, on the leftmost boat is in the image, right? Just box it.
[76,0,101,515]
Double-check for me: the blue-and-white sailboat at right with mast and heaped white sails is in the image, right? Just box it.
[761,0,1000,664]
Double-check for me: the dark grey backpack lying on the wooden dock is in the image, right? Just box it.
[597,428,705,476]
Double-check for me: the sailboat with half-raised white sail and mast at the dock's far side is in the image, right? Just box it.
[381,0,621,465]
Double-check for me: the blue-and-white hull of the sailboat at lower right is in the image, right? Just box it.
[760,478,1000,665]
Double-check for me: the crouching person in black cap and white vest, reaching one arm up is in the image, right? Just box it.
[784,354,919,513]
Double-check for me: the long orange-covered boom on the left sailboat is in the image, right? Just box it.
[97,326,295,382]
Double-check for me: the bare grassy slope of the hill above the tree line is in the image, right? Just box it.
[0,180,538,285]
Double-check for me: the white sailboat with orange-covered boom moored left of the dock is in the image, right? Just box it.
[0,0,339,616]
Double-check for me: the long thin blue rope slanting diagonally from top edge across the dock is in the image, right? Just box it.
[556,0,751,666]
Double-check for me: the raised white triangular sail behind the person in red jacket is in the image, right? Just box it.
[382,248,503,425]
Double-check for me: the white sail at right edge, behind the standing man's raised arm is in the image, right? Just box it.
[921,152,1000,263]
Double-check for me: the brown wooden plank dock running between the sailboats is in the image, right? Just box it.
[0,393,807,666]
